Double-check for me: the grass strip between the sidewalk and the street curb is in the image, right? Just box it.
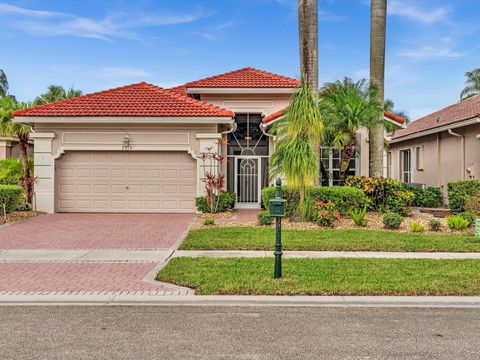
[157,258,480,295]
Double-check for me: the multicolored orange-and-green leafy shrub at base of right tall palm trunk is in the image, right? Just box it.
[346,176,415,216]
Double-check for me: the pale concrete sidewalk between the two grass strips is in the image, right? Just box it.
[172,250,480,259]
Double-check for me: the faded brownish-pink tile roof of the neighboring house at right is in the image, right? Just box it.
[392,95,480,140]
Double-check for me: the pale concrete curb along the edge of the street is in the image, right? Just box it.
[0,292,480,308]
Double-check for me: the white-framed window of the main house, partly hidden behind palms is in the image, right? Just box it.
[320,146,356,186]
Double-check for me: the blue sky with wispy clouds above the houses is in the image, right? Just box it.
[0,0,480,119]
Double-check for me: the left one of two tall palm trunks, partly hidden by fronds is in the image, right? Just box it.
[298,0,320,185]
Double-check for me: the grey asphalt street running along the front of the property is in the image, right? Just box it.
[0,305,480,360]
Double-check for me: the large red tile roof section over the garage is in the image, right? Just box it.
[13,82,234,117]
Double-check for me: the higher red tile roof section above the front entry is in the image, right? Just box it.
[172,67,300,91]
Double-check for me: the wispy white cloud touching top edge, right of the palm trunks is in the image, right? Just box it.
[388,0,449,25]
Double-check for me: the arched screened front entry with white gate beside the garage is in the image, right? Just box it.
[227,114,268,208]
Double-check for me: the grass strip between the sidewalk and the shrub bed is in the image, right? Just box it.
[180,227,480,252]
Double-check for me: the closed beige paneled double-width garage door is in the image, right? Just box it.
[56,151,196,213]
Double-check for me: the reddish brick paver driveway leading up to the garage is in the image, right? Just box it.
[0,214,195,294]
